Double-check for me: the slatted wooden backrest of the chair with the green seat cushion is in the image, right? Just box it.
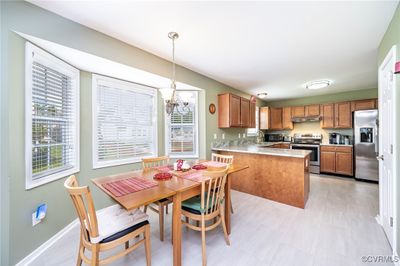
[200,166,228,215]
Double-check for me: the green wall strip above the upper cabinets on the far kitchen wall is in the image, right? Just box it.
[267,88,378,107]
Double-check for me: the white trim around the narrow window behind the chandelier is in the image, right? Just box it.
[163,90,200,159]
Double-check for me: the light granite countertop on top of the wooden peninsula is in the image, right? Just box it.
[212,142,311,158]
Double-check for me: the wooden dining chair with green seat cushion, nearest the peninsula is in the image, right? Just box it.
[182,167,230,266]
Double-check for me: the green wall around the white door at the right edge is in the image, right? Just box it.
[378,4,400,254]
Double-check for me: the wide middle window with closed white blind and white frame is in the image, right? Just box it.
[93,75,157,168]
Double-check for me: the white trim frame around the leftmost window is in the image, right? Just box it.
[25,42,80,190]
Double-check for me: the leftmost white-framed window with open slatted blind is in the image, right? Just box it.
[26,43,79,188]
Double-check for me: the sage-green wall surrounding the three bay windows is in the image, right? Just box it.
[0,1,261,265]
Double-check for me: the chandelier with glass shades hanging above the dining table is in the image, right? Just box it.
[160,32,190,115]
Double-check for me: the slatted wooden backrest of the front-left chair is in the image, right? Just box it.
[64,175,99,241]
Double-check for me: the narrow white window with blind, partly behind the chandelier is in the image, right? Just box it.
[165,91,198,158]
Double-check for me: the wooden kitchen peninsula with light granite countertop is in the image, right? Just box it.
[212,143,311,208]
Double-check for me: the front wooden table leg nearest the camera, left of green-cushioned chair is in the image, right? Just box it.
[172,193,182,266]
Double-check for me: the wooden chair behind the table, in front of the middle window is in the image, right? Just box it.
[142,156,172,241]
